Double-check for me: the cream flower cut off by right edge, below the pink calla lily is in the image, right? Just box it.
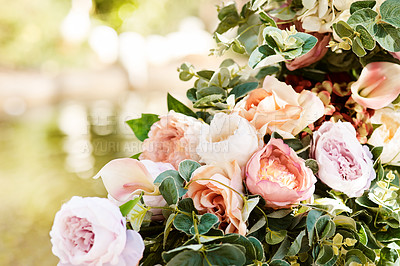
[368,107,400,163]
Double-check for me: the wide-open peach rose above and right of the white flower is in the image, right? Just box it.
[233,76,324,137]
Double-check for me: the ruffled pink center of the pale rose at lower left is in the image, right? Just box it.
[64,216,94,253]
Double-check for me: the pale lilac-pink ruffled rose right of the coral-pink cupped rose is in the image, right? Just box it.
[311,121,375,197]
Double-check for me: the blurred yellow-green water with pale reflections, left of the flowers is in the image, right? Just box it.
[0,101,140,265]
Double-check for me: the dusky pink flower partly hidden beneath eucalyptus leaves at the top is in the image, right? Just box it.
[286,32,331,71]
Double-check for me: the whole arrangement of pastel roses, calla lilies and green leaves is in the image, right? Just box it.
[50,0,400,266]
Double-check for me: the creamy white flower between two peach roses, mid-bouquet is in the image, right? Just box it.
[197,113,258,167]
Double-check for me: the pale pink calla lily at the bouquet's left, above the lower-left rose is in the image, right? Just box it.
[94,158,174,218]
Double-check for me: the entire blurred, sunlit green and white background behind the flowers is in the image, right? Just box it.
[0,0,231,265]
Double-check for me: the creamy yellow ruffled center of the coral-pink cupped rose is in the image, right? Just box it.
[258,157,298,189]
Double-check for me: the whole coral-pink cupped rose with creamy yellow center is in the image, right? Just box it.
[246,139,317,208]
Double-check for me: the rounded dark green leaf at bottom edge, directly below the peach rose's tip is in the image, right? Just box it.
[206,244,246,265]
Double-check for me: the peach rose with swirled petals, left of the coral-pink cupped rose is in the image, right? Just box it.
[187,161,246,235]
